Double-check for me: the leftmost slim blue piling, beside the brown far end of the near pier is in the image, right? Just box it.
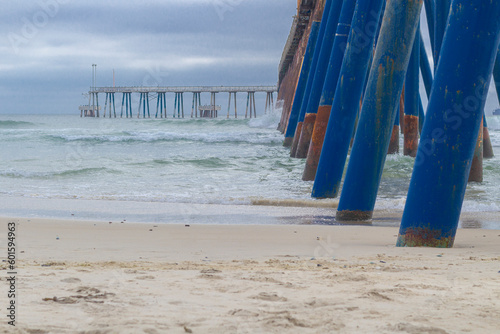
[283,0,333,147]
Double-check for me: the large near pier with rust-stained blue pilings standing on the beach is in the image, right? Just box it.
[278,0,500,247]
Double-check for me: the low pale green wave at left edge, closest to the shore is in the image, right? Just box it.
[0,168,120,180]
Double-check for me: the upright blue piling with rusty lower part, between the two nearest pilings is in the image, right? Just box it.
[403,22,420,157]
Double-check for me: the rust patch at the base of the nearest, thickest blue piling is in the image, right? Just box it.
[397,227,455,248]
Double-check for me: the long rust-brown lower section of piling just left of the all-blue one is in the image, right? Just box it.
[302,106,332,181]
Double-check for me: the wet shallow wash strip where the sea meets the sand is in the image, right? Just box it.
[0,195,500,230]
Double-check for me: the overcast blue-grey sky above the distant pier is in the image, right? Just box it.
[0,0,297,114]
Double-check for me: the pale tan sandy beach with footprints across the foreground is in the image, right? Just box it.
[0,219,500,334]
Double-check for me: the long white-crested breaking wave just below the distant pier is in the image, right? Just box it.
[46,132,282,145]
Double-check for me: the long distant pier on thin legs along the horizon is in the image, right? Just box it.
[79,86,278,118]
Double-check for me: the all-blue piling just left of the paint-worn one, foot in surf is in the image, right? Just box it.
[308,0,385,189]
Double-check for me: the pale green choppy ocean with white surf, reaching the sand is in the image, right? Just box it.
[0,110,500,229]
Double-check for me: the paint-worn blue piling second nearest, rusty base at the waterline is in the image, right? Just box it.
[336,0,423,221]
